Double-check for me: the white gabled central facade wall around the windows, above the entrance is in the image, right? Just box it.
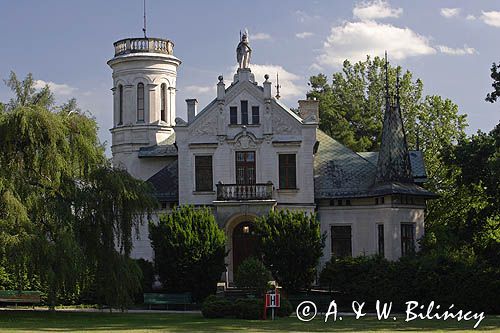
[175,74,317,207]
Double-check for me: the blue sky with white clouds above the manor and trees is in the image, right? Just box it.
[0,0,500,153]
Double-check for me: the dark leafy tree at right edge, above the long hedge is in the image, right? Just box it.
[426,120,500,265]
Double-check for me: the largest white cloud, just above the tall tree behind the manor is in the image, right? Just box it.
[317,21,436,67]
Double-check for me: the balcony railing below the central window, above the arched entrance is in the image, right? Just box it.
[217,182,273,201]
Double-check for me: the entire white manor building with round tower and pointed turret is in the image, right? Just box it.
[108,33,434,281]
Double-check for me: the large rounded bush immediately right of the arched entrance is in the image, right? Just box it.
[255,210,326,292]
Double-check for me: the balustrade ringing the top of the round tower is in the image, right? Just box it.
[113,38,174,57]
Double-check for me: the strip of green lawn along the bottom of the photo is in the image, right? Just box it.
[0,311,500,333]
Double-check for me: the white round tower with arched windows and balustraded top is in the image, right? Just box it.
[108,37,181,179]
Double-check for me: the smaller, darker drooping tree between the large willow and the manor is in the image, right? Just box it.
[75,165,157,308]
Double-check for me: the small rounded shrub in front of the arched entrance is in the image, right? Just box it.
[234,258,272,296]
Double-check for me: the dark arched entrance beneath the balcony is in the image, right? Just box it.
[232,221,258,276]
